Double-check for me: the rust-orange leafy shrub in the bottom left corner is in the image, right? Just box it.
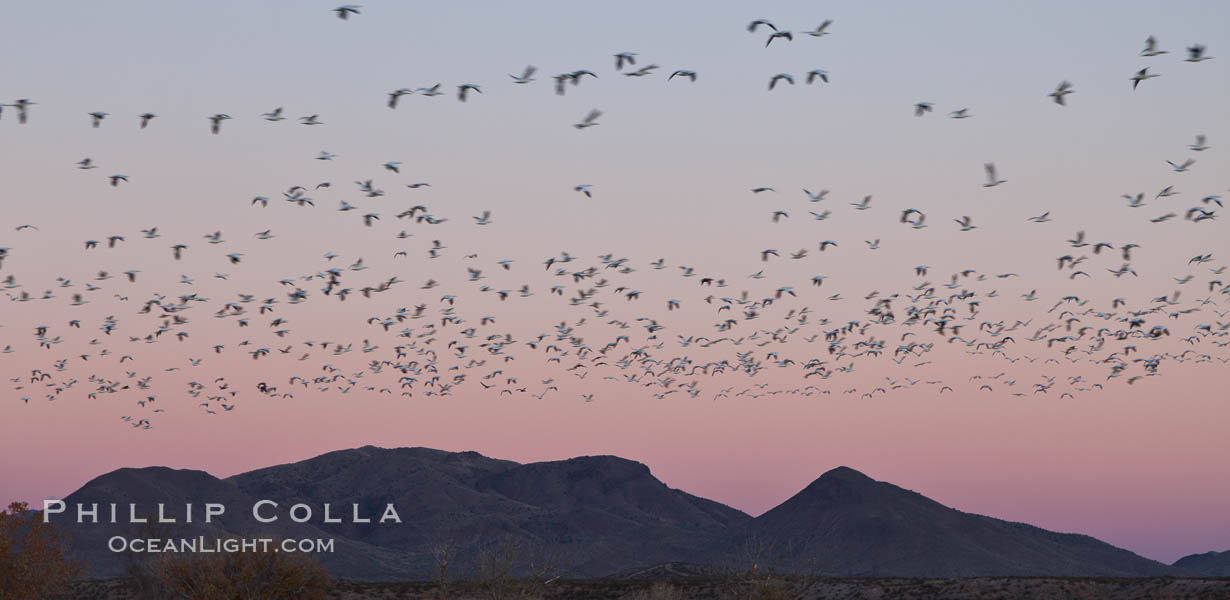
[0,502,82,600]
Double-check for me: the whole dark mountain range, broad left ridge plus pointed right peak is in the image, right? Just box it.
[53,446,1203,580]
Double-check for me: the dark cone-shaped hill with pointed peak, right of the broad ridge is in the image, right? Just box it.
[749,467,1175,577]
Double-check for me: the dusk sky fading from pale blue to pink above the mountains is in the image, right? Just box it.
[0,0,1230,562]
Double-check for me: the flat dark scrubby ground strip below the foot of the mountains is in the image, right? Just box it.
[70,577,1230,600]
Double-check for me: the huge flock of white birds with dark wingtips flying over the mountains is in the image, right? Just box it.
[0,5,1230,429]
